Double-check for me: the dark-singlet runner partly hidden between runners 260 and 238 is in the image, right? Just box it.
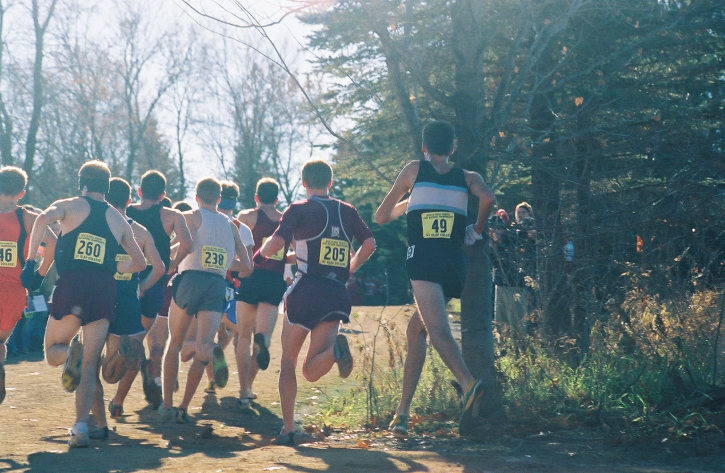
[126,171,191,409]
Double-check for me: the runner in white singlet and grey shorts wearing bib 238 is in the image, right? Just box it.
[162,178,252,423]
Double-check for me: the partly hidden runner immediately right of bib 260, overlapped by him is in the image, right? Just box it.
[101,177,166,424]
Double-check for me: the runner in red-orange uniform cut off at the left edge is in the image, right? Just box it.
[0,166,55,404]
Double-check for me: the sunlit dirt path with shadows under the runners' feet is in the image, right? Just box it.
[0,307,725,473]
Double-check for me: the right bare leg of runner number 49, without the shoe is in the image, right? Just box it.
[410,281,473,392]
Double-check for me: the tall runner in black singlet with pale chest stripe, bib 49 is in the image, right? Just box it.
[375,121,496,437]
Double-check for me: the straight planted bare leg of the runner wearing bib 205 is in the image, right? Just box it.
[279,317,308,434]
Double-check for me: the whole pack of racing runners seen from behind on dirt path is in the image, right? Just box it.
[0,121,495,447]
